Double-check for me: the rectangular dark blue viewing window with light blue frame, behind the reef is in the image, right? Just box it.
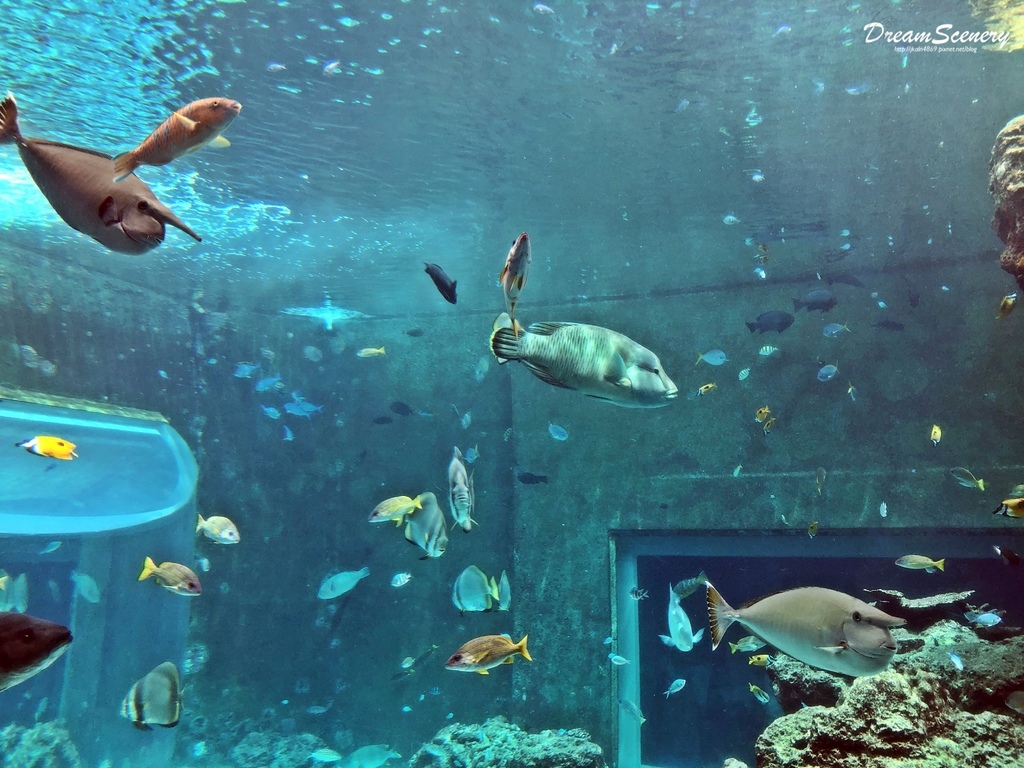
[611,530,1024,768]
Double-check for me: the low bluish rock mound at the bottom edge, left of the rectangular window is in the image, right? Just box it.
[409,717,605,768]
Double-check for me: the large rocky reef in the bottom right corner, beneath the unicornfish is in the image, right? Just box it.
[756,621,1024,768]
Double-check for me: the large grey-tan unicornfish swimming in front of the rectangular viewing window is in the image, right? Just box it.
[708,583,906,677]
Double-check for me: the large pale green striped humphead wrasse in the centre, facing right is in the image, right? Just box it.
[490,312,679,408]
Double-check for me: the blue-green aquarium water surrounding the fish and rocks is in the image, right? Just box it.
[0,0,1024,768]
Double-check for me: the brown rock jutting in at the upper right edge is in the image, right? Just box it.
[988,115,1024,290]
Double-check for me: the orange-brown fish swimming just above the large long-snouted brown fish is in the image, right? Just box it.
[114,97,242,181]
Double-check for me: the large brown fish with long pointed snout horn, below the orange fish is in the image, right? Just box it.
[0,93,203,255]
